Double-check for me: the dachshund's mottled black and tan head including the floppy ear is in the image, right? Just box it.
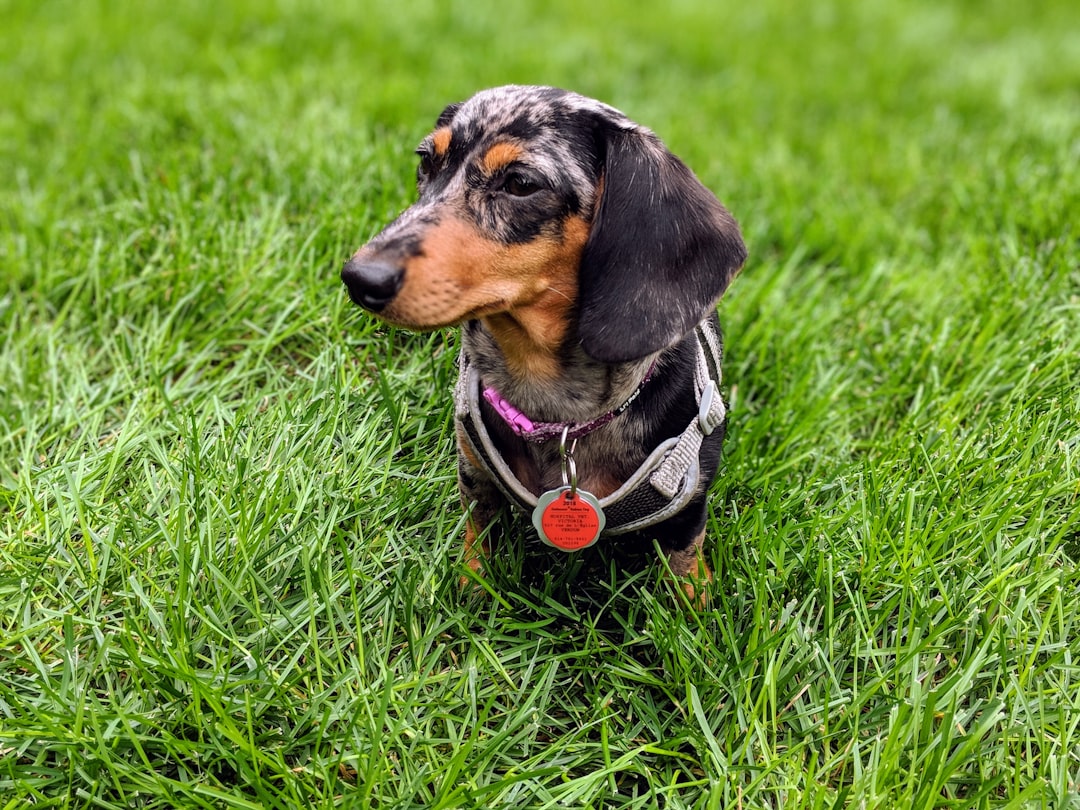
[341,86,746,363]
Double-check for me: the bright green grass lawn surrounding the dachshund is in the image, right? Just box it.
[0,0,1080,810]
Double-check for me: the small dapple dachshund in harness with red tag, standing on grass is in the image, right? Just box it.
[341,85,746,598]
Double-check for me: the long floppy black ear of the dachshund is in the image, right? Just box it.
[578,126,746,363]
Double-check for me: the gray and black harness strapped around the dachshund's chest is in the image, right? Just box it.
[455,320,727,535]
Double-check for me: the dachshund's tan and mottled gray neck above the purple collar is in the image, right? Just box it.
[461,316,653,422]
